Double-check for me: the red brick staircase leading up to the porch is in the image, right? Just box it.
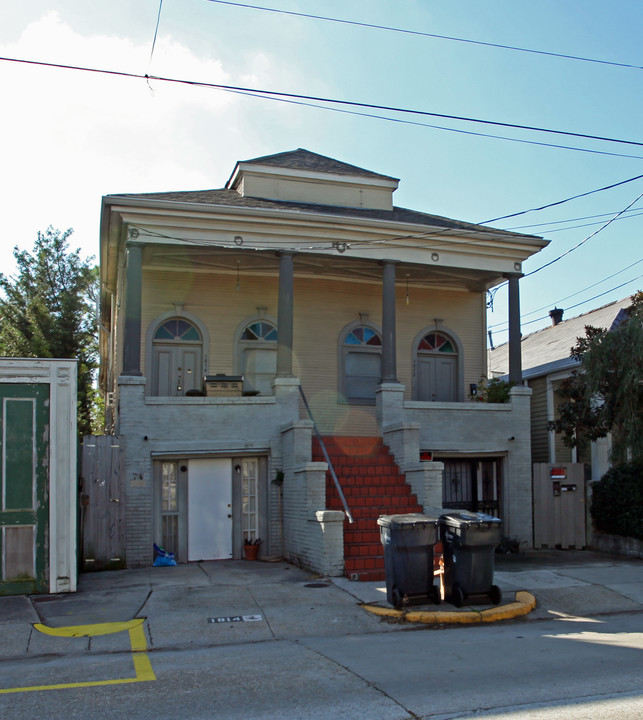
[312,435,422,581]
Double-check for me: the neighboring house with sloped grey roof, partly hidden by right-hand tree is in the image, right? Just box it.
[489,297,632,481]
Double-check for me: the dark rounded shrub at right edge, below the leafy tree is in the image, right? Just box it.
[591,463,643,540]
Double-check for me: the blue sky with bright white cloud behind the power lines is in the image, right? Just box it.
[0,0,643,344]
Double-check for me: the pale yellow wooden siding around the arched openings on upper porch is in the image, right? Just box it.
[141,268,485,434]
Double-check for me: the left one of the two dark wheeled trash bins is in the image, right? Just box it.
[377,513,440,608]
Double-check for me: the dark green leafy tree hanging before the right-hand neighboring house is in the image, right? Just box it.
[551,292,643,464]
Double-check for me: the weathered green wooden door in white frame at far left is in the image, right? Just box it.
[0,383,49,595]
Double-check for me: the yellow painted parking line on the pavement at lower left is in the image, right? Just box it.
[0,618,156,695]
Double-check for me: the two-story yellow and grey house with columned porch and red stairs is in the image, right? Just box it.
[100,149,546,578]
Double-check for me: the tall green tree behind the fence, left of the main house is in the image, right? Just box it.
[0,227,98,436]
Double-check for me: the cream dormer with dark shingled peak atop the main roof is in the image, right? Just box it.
[226,148,399,210]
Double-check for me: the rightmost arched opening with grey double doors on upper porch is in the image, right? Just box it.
[415,330,460,402]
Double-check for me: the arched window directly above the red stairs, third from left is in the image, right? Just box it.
[340,325,382,405]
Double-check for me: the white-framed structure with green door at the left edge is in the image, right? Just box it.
[0,358,78,595]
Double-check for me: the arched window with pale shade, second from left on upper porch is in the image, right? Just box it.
[239,319,277,395]
